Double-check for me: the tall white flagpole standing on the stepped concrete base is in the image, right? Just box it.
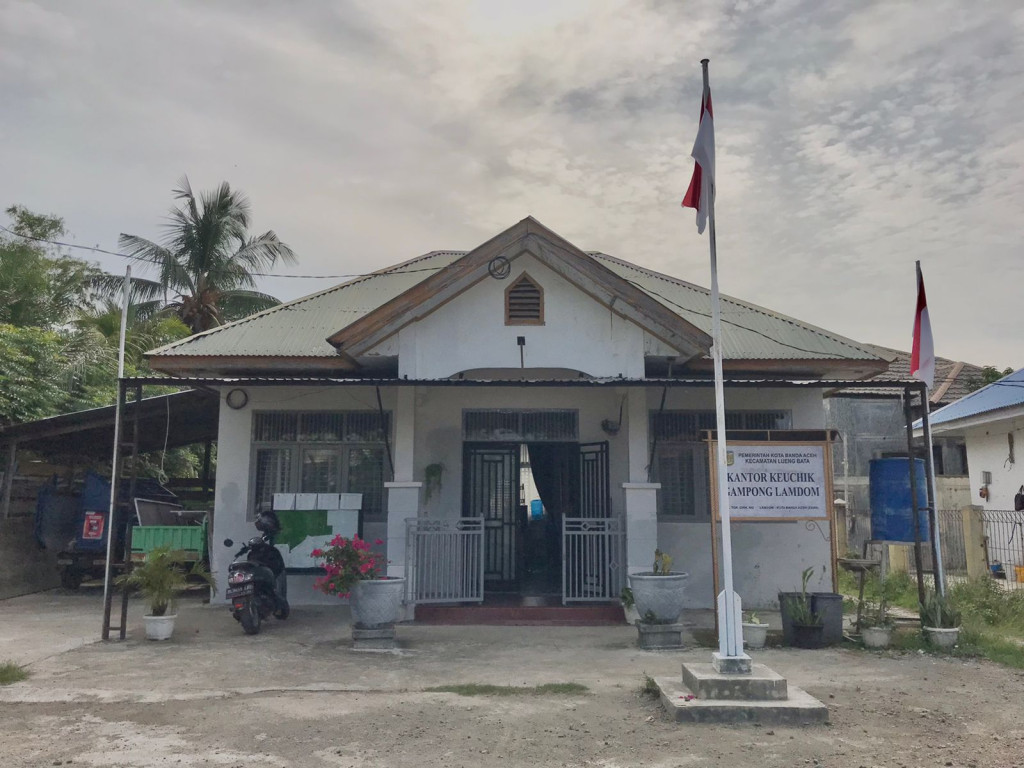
[700,58,749,658]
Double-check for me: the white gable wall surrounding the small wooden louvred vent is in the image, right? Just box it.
[368,254,656,379]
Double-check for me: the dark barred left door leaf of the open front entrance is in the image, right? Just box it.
[462,442,524,592]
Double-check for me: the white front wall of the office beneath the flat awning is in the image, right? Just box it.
[212,386,835,607]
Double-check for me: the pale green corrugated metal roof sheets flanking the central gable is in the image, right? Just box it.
[152,251,878,360]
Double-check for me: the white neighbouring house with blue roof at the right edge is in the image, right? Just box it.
[919,369,1024,582]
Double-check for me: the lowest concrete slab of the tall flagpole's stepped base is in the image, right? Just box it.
[654,677,828,725]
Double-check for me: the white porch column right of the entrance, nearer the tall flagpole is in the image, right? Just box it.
[623,387,662,573]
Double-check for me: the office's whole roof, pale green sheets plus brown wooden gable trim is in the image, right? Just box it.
[148,218,885,378]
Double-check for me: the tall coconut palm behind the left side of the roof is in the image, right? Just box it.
[118,178,295,333]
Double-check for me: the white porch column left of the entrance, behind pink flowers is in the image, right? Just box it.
[384,387,423,578]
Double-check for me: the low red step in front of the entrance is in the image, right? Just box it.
[416,603,626,627]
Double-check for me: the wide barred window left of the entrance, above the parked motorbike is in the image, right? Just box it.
[250,411,391,520]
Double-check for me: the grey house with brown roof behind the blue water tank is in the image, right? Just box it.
[825,344,984,552]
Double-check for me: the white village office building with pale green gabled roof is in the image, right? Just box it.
[148,218,887,607]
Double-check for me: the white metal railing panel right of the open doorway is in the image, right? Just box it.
[562,517,626,603]
